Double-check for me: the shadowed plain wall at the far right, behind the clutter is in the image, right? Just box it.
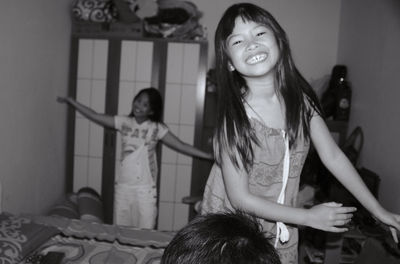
[338,0,400,212]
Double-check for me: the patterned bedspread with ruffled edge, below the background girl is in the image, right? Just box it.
[22,216,174,264]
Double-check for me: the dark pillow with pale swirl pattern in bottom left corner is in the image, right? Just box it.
[0,213,59,264]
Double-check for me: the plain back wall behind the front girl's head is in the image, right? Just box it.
[192,0,341,84]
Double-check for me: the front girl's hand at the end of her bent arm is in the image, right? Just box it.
[307,202,357,233]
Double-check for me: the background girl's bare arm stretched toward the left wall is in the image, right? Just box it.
[57,97,114,128]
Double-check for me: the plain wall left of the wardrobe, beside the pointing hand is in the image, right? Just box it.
[0,0,71,213]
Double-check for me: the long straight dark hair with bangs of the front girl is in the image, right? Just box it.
[214,3,322,172]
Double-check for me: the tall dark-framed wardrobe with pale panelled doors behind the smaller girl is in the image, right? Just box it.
[67,25,208,230]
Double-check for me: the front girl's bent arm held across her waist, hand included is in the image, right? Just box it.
[221,147,356,232]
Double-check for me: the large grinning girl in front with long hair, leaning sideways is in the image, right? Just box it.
[201,3,400,263]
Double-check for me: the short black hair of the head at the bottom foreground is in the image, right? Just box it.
[161,211,281,264]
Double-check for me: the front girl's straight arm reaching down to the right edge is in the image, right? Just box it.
[310,115,400,242]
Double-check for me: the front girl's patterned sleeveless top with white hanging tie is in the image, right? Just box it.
[201,118,310,264]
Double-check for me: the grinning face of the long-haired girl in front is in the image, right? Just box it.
[226,17,280,78]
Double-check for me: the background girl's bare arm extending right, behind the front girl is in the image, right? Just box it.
[161,131,214,160]
